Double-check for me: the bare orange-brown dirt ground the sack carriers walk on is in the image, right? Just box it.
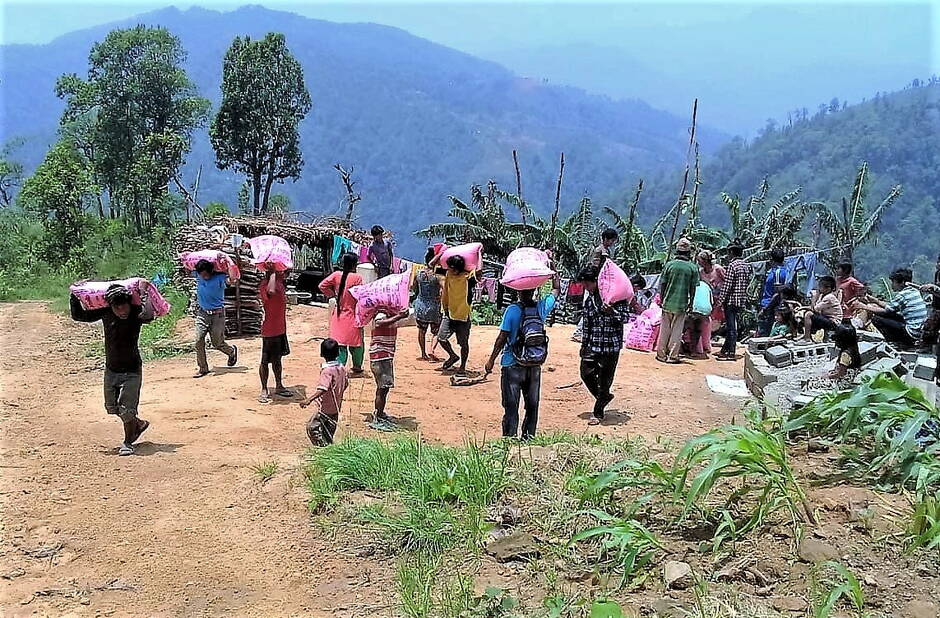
[0,303,740,616]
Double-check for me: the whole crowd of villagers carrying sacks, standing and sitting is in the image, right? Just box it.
[71,221,940,455]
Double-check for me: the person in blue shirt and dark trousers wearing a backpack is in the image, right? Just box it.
[486,274,561,440]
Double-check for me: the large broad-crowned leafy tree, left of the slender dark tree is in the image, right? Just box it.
[56,26,209,232]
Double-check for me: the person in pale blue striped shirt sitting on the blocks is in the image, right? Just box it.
[853,268,927,348]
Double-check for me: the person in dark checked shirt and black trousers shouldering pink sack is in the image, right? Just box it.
[578,266,627,425]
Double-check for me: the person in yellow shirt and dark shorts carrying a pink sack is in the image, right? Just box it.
[438,255,477,374]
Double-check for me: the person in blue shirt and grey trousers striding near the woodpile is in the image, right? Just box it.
[193,255,238,378]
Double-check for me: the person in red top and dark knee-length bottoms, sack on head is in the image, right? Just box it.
[258,267,294,403]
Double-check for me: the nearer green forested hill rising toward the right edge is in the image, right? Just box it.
[640,82,940,276]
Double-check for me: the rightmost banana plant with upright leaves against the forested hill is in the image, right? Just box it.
[807,161,902,264]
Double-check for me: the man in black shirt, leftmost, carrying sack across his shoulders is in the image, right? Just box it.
[69,284,153,455]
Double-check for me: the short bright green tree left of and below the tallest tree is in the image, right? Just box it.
[18,140,98,262]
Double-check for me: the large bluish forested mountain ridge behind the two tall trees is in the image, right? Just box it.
[0,6,723,250]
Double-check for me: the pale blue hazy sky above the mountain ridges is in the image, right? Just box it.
[0,0,940,135]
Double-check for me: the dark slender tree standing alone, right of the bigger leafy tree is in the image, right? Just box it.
[209,33,311,215]
